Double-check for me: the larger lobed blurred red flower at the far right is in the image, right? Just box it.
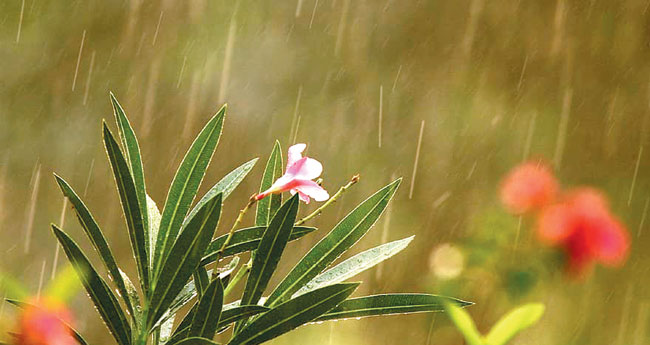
[537,188,629,276]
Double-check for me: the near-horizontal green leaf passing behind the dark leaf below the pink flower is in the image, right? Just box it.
[201,226,316,265]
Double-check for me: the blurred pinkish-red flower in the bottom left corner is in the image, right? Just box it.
[14,298,76,345]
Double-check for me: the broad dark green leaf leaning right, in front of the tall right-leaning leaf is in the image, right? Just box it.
[146,194,221,327]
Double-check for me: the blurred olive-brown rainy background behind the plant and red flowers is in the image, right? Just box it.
[0,0,650,345]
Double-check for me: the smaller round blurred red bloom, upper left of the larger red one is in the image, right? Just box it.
[500,161,558,214]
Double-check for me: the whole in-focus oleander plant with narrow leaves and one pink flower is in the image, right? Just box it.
[8,94,471,345]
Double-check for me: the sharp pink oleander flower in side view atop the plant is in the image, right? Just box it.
[255,144,330,204]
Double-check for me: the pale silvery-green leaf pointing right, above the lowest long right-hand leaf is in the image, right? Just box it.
[293,236,415,297]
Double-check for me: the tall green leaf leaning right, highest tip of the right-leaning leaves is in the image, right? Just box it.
[154,105,226,277]
